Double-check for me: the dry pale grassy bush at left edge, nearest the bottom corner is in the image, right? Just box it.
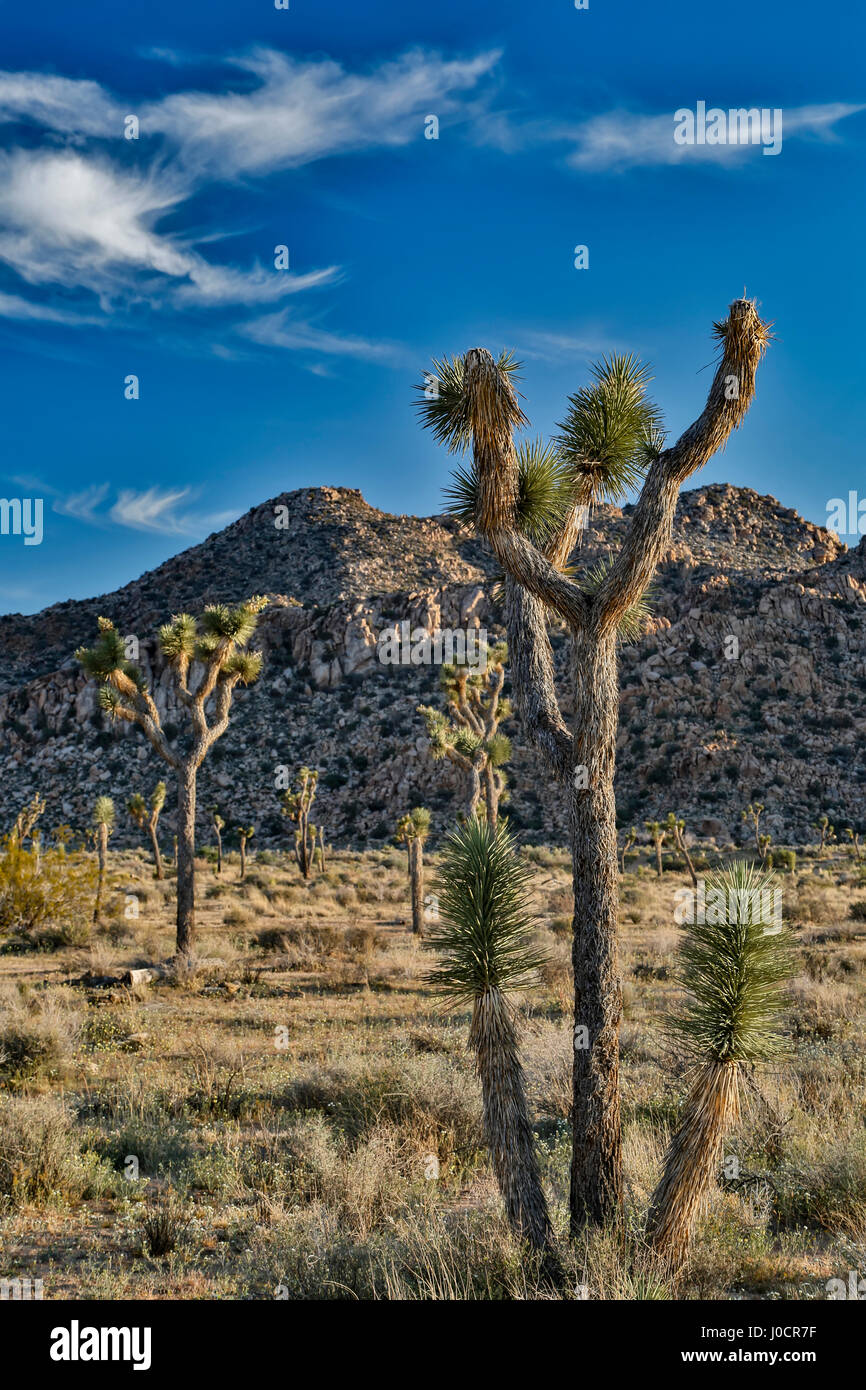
[0,1095,118,1207]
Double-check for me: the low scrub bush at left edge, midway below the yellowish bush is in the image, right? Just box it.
[0,986,81,1083]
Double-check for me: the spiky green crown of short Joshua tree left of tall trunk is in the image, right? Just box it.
[427,816,545,1004]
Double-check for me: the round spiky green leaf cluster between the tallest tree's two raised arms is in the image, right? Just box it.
[555,353,663,503]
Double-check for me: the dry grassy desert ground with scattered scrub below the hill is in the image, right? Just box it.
[0,844,866,1300]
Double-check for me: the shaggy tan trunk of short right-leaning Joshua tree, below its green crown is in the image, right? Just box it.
[646,1062,740,1268]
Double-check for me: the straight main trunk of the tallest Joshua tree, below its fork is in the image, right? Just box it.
[570,632,623,1230]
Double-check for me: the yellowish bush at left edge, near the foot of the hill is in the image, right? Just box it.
[0,837,97,948]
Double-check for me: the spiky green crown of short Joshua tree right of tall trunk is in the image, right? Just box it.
[669,860,792,1062]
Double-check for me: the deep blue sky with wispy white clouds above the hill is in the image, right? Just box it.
[0,0,866,613]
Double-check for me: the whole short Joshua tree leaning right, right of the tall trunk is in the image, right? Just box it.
[648,862,792,1266]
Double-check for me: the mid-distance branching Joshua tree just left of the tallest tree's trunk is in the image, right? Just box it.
[418,642,512,826]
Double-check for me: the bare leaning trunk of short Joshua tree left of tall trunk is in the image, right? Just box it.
[470,988,550,1250]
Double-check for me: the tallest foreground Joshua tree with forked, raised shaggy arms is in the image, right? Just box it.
[418,299,769,1229]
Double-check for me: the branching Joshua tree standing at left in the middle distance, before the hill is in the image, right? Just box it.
[75,598,267,958]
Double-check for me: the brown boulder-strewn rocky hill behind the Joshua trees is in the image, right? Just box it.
[0,485,866,845]
